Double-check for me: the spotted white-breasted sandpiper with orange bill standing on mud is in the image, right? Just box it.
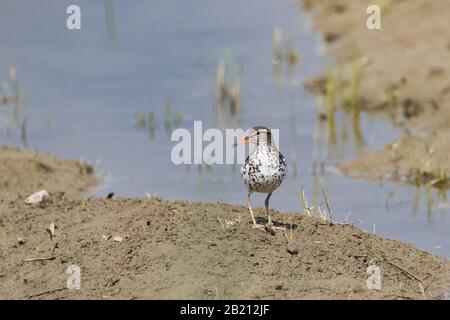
[234,126,287,234]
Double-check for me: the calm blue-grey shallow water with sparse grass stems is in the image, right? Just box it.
[0,0,450,258]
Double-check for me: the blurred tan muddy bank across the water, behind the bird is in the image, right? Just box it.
[301,0,450,188]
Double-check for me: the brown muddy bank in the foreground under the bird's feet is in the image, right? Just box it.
[0,148,450,299]
